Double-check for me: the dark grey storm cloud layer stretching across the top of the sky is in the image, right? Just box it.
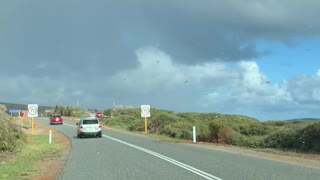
[0,0,320,73]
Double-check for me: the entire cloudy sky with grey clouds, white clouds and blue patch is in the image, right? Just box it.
[0,0,320,121]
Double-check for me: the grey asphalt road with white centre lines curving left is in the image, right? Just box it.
[36,118,320,180]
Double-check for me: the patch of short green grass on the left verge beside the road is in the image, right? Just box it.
[0,135,62,180]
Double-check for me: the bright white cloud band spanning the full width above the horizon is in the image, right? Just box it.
[0,47,320,120]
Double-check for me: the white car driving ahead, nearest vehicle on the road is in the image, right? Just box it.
[77,117,102,138]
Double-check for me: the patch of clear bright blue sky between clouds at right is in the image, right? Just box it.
[255,38,320,83]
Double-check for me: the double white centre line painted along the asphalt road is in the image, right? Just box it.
[64,123,222,180]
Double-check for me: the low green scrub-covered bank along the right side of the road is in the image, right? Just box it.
[103,108,320,153]
